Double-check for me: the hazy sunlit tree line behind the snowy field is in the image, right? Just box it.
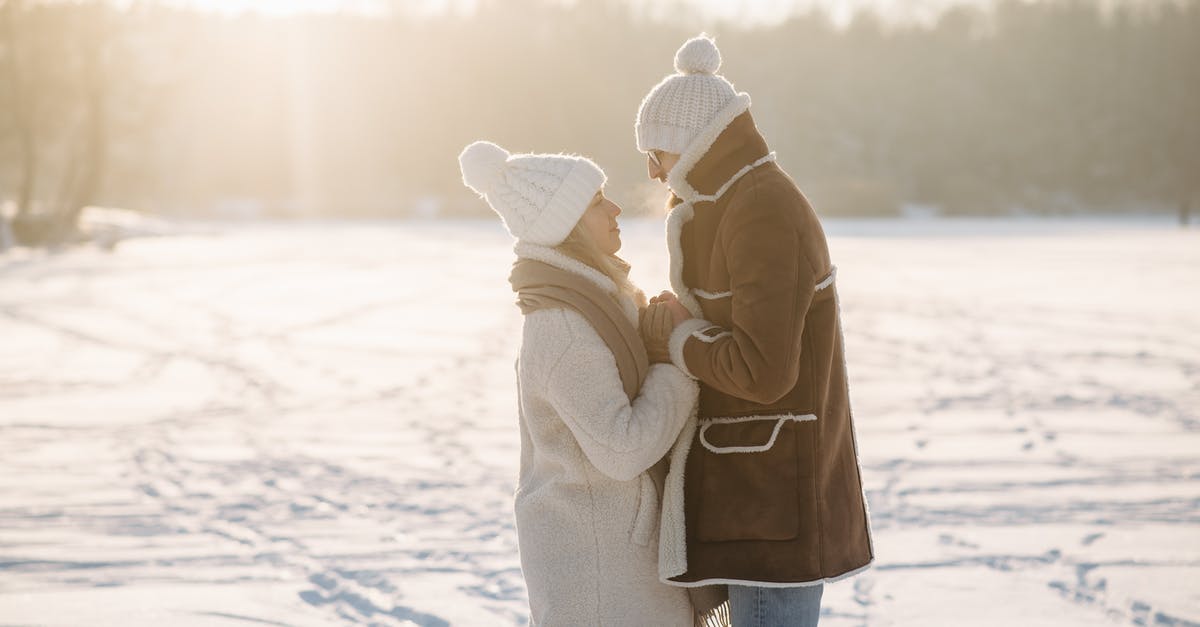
[0,0,1200,238]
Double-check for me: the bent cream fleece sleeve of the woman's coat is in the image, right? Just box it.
[546,309,698,480]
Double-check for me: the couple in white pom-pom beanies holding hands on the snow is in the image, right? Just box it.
[460,36,874,627]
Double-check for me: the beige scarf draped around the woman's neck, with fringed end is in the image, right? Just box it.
[509,258,730,627]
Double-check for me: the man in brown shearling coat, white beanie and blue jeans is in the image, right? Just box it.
[636,36,875,627]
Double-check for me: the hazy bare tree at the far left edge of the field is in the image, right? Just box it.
[0,0,171,245]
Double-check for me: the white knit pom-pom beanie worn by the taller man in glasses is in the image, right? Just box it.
[635,35,749,154]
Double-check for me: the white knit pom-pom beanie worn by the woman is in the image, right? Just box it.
[458,142,606,246]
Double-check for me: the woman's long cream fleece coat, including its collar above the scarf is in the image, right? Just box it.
[514,243,698,627]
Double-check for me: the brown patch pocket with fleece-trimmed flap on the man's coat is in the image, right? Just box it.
[695,414,816,542]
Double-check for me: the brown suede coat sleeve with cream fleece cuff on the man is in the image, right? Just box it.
[670,189,816,404]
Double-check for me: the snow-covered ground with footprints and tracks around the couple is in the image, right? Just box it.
[0,220,1200,627]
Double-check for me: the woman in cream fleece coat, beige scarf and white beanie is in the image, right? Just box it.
[458,142,697,626]
